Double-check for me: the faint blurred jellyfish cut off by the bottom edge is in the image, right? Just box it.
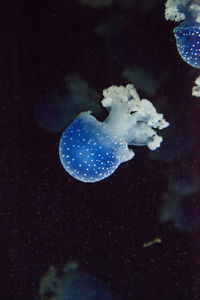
[39,262,112,300]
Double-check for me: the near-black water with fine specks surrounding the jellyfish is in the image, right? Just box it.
[0,0,200,300]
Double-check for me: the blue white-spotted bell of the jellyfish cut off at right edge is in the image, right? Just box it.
[174,22,200,68]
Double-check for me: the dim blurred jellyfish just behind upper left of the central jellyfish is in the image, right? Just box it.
[35,74,101,132]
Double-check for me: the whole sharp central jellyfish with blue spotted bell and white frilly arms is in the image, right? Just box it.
[59,84,169,182]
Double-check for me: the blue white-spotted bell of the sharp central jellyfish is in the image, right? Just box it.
[60,112,134,182]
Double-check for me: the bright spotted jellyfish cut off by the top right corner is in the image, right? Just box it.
[165,0,200,68]
